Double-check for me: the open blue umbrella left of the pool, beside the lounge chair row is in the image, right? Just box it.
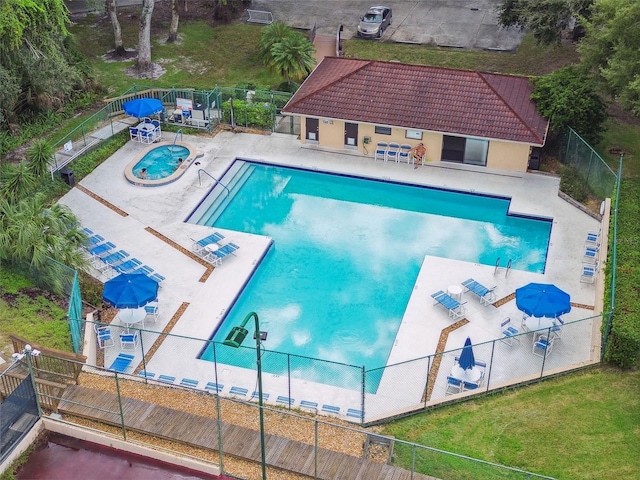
[102,273,158,308]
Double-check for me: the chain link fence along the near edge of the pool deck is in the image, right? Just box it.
[88,315,602,425]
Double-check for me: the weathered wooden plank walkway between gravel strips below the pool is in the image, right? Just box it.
[58,385,436,480]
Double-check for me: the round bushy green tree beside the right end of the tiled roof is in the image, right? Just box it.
[531,65,607,144]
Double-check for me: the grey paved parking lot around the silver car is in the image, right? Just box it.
[251,0,522,51]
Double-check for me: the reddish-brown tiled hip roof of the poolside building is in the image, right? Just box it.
[282,57,548,145]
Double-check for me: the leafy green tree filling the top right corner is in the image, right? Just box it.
[578,0,640,116]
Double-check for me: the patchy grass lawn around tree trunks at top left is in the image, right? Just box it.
[70,16,284,96]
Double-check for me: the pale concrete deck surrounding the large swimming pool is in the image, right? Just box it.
[60,132,599,417]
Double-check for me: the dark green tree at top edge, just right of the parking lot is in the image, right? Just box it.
[496,0,593,44]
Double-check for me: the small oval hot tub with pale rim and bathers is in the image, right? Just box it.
[124,142,203,187]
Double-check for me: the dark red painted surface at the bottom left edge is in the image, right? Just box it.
[17,433,238,480]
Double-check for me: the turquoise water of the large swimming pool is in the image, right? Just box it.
[192,164,551,390]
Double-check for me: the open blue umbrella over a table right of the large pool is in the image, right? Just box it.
[516,283,571,318]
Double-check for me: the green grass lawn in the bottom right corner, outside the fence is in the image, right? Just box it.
[384,367,640,480]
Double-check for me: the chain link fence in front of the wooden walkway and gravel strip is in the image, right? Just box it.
[3,344,551,479]
